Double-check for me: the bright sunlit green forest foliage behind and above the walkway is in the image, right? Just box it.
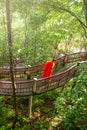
[0,0,87,65]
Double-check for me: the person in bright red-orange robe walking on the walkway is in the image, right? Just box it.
[42,58,56,78]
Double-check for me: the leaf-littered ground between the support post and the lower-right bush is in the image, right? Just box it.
[23,98,63,130]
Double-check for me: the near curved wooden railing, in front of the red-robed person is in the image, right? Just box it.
[0,65,77,96]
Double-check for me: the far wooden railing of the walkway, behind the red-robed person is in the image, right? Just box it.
[0,52,87,79]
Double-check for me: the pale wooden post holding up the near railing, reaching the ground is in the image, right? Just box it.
[29,78,37,118]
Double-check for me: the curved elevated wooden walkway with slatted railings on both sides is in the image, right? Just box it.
[0,52,87,96]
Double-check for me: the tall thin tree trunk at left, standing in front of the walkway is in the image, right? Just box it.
[6,0,17,124]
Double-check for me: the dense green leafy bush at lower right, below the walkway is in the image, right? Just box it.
[55,64,87,130]
